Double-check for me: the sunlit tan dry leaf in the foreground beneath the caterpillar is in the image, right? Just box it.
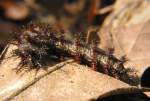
[0,45,149,101]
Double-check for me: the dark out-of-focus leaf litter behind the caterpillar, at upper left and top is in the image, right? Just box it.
[0,0,115,51]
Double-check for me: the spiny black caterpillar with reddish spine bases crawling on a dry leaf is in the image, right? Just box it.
[14,22,138,83]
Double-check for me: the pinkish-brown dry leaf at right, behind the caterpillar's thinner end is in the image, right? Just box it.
[99,21,150,75]
